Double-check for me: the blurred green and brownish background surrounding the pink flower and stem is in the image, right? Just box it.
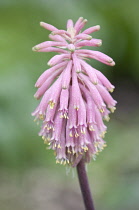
[0,0,139,210]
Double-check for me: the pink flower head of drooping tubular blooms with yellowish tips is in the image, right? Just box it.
[32,17,116,167]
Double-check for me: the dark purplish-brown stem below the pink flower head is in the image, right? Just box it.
[77,159,95,210]
